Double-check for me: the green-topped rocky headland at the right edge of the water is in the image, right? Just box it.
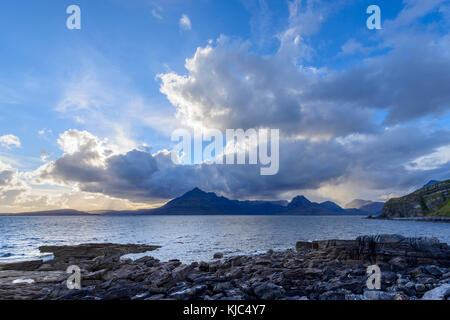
[381,180,450,218]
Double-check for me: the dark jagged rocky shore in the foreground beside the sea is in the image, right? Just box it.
[0,235,450,300]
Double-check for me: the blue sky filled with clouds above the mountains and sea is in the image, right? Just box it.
[0,0,450,213]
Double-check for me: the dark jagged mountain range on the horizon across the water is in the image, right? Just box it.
[2,188,382,216]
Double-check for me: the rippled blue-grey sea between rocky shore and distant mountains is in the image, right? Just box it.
[0,216,450,262]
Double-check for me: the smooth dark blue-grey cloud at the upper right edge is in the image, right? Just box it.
[306,35,450,125]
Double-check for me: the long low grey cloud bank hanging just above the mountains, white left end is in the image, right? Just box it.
[37,127,450,203]
